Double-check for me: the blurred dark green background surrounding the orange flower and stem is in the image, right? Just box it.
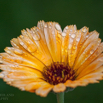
[0,0,103,103]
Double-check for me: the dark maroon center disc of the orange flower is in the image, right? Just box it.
[43,63,75,85]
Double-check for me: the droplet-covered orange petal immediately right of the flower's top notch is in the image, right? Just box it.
[61,25,76,63]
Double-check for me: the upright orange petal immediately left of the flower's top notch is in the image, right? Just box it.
[44,22,62,62]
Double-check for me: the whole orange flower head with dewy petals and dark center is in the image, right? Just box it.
[0,21,103,97]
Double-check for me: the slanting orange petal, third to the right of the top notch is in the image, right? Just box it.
[73,31,100,70]
